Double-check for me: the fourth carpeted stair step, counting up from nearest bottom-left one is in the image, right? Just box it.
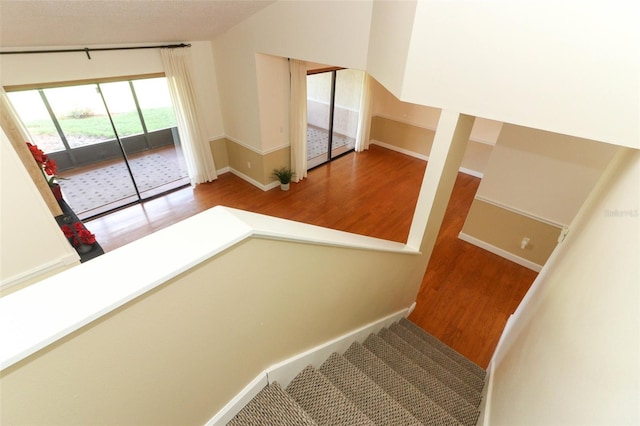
[344,342,461,426]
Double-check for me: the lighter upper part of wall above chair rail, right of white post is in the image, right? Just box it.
[477,124,616,225]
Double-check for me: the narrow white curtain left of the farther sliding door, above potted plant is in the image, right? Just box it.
[289,59,307,182]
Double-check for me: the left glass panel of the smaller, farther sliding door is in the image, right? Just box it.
[307,72,333,168]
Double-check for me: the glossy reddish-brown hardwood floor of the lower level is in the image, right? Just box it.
[87,145,536,367]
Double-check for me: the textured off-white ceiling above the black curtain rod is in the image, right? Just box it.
[0,0,273,48]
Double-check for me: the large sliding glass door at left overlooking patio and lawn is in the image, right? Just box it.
[8,78,188,219]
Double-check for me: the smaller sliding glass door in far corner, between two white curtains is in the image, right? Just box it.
[307,69,364,169]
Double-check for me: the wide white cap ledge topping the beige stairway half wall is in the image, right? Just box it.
[0,206,418,370]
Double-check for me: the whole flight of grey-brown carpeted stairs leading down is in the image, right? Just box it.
[228,319,486,426]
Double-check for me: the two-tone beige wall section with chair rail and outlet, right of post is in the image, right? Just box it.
[461,123,616,269]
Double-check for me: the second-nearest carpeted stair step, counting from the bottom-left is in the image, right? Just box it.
[287,366,375,426]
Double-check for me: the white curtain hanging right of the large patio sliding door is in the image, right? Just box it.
[160,48,218,185]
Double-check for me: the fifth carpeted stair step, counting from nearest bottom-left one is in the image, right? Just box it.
[363,334,479,426]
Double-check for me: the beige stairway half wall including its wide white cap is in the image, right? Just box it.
[0,207,421,425]
